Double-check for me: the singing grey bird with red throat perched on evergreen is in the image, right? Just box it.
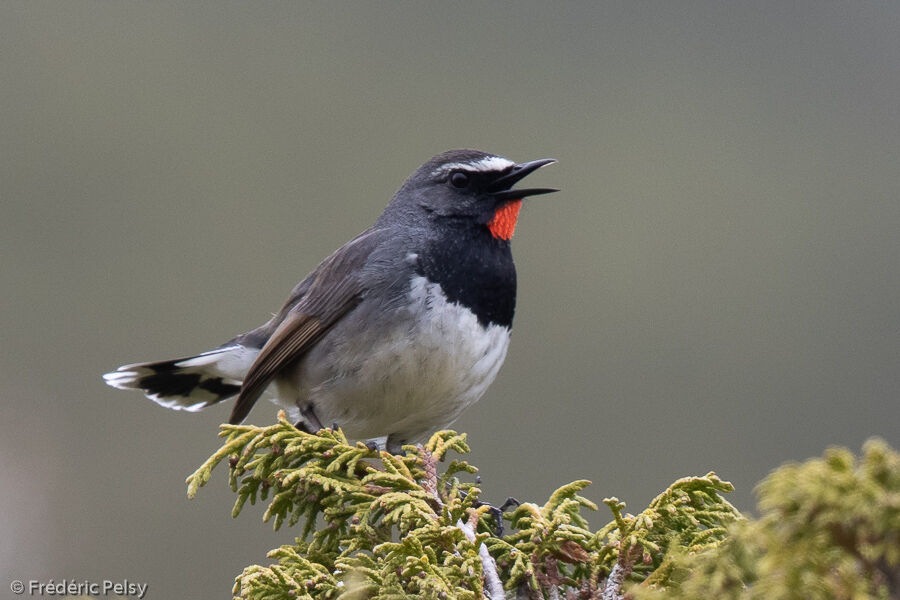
[103,149,558,453]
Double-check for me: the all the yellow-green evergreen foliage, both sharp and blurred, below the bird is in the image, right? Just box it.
[188,415,900,600]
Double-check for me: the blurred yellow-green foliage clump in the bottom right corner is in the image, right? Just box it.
[632,440,900,600]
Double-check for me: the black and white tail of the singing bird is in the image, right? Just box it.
[103,345,259,412]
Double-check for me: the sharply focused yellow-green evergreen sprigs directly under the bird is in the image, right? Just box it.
[187,415,741,600]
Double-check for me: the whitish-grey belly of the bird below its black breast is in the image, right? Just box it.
[278,277,509,443]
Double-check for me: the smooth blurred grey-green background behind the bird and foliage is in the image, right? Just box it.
[0,1,900,598]
